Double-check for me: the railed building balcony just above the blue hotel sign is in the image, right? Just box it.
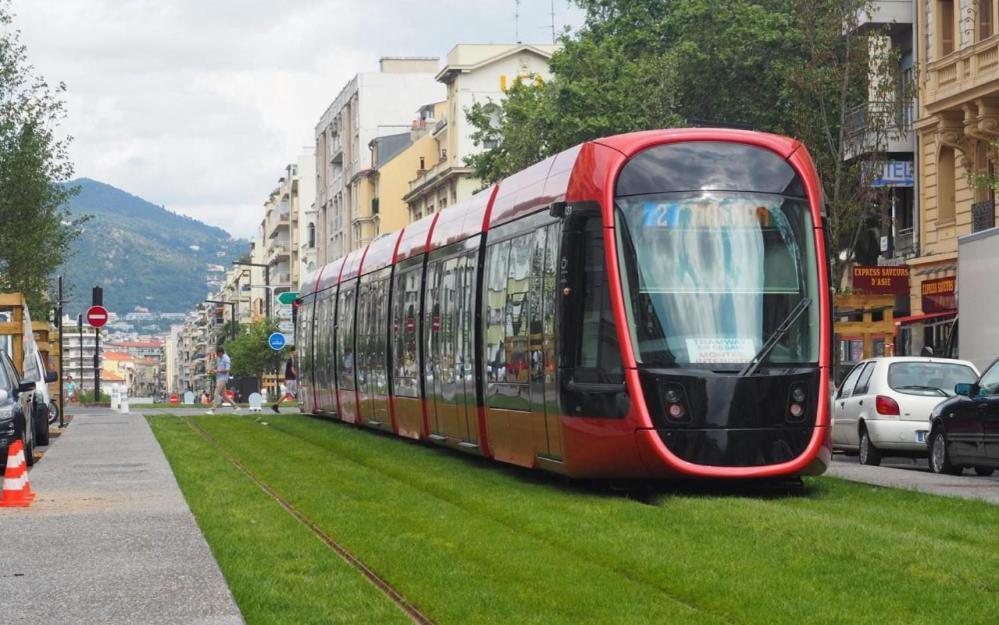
[844,101,916,160]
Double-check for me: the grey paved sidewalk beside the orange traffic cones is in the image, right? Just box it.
[0,410,243,625]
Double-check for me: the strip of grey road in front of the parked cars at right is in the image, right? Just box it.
[826,455,999,504]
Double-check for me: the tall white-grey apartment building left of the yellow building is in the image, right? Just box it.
[315,57,443,265]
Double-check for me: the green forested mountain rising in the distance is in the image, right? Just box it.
[62,178,249,317]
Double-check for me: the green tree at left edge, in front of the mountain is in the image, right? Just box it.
[0,0,85,308]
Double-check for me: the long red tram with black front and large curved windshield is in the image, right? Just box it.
[296,129,831,478]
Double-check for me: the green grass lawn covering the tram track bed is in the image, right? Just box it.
[150,414,999,625]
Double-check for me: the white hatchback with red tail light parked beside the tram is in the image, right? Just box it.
[833,357,978,466]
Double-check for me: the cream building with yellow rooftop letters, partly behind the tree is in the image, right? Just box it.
[404,44,556,221]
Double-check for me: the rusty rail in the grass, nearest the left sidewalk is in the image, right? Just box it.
[177,415,436,625]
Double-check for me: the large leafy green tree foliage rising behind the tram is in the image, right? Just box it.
[467,0,911,286]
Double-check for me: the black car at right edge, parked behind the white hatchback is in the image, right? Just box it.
[926,360,999,475]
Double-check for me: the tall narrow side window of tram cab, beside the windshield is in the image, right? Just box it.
[574,219,624,382]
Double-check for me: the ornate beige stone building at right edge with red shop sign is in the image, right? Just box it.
[909,0,999,347]
